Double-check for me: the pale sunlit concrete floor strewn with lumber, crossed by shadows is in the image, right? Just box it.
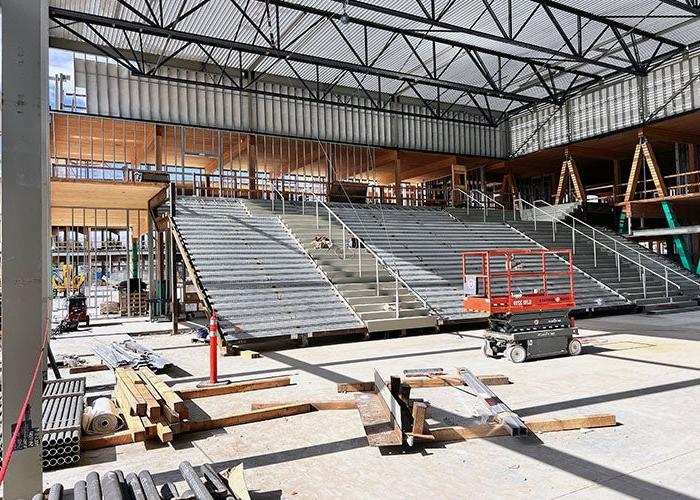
[44,313,700,499]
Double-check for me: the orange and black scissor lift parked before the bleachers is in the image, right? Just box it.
[462,249,581,363]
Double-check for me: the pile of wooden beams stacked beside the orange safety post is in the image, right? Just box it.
[114,368,189,443]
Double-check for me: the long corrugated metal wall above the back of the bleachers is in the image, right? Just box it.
[74,57,505,156]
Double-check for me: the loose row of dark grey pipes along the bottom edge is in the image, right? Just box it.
[32,462,241,500]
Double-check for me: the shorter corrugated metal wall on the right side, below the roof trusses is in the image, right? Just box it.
[510,52,700,156]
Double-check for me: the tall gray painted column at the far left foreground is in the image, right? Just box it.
[2,0,49,498]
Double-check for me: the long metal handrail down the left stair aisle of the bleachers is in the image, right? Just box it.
[301,192,438,319]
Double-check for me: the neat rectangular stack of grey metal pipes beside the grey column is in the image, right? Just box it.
[41,377,85,469]
